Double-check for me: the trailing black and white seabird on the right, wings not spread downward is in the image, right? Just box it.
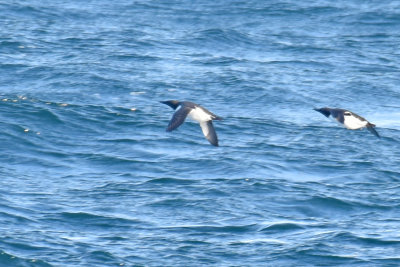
[314,108,380,137]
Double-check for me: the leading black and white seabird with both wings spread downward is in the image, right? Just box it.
[161,100,222,146]
